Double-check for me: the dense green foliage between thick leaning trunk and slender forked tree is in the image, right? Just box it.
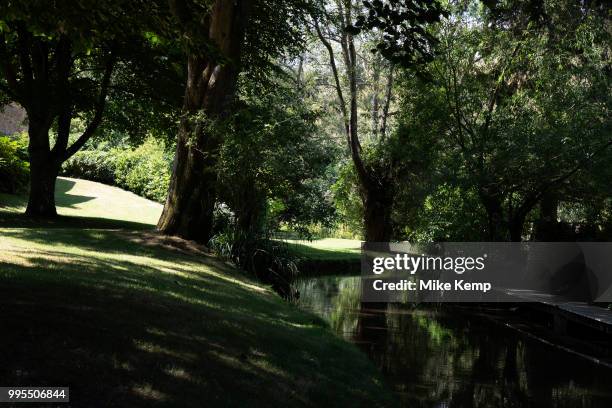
[219,80,334,234]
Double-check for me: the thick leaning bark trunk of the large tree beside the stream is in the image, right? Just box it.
[157,0,250,242]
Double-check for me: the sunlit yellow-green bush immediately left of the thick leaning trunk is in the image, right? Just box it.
[112,139,171,202]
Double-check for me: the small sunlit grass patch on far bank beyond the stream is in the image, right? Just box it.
[286,238,361,261]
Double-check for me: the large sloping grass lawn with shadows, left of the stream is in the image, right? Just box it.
[0,179,393,407]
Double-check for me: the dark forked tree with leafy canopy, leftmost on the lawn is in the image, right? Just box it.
[0,0,160,217]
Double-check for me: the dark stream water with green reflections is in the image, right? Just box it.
[298,277,612,408]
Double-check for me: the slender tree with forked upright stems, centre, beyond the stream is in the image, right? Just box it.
[313,0,443,242]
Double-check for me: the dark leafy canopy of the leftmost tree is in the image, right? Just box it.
[0,0,164,127]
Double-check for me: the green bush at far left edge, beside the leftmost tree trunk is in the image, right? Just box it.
[0,136,30,194]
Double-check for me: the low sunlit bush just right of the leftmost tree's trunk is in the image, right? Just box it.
[62,150,116,185]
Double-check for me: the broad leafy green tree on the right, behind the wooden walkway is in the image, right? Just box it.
[414,2,612,241]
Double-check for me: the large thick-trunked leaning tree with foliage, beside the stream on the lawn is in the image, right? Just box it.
[157,0,307,242]
